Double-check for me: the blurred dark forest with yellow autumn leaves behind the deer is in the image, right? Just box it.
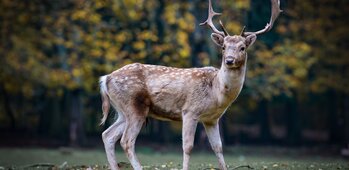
[0,0,349,150]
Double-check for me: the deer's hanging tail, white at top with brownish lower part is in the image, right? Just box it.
[99,75,110,125]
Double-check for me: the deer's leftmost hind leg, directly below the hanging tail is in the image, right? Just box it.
[102,113,126,170]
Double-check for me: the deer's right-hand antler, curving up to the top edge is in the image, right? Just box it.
[243,0,282,36]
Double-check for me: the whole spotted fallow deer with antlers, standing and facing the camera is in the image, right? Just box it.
[100,0,281,170]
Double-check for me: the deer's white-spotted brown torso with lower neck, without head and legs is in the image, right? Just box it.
[101,60,246,125]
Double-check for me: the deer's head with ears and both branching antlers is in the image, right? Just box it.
[200,0,282,69]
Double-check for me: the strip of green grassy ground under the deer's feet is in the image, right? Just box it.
[0,147,349,170]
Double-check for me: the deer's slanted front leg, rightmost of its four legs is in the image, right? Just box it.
[204,120,227,170]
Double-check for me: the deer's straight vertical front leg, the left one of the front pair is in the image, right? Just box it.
[182,113,198,170]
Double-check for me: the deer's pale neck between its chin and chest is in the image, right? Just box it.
[214,59,247,105]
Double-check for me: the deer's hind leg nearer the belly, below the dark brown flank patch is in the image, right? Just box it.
[120,107,149,170]
